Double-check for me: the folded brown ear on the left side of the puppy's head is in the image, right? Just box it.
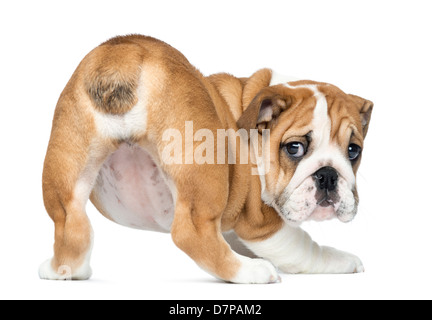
[237,88,292,132]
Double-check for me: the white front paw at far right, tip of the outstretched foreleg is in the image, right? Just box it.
[322,247,365,273]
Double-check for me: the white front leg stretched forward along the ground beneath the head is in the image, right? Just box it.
[242,224,364,273]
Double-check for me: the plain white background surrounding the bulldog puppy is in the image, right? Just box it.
[0,0,432,299]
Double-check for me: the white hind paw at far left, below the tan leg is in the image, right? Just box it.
[39,259,92,280]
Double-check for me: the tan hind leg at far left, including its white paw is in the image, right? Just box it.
[39,104,109,280]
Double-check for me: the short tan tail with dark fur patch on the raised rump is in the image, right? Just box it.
[84,36,143,114]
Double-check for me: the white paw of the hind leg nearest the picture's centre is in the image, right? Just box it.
[230,255,281,283]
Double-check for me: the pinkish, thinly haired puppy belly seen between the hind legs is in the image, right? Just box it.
[92,144,174,232]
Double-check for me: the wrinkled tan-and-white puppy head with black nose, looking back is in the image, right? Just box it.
[238,71,373,224]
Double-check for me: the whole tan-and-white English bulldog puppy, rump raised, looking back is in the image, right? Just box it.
[39,35,373,283]
